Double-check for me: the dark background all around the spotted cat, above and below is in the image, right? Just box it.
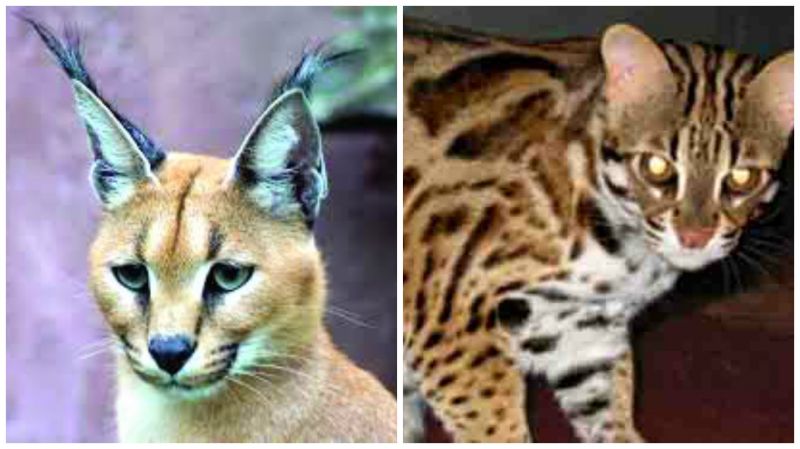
[404,7,794,442]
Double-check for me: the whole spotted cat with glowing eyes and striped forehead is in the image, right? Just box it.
[403,19,794,442]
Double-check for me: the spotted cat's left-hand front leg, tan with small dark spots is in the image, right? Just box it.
[421,346,531,443]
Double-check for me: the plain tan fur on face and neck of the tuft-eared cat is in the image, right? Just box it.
[90,153,396,442]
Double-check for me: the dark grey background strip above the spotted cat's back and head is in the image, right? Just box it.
[403,6,794,55]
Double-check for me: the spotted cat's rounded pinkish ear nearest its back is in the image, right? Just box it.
[600,24,677,113]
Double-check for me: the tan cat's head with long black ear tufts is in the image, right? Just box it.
[29,20,332,399]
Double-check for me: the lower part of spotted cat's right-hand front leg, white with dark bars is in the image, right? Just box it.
[551,351,644,443]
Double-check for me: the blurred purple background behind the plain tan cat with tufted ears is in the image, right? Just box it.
[6,7,397,442]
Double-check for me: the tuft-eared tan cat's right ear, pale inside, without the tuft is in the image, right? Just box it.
[232,89,328,226]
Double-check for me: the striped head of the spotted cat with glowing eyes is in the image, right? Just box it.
[598,25,794,270]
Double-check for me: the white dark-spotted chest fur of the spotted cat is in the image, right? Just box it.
[512,228,678,379]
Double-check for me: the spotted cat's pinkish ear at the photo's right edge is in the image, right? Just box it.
[737,51,794,145]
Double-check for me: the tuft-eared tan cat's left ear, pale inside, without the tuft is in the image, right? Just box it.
[72,80,158,209]
